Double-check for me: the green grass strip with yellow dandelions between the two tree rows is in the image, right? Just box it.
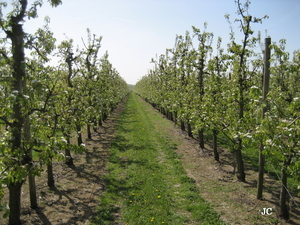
[91,94,225,225]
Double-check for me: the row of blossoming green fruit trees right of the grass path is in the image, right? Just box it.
[134,1,300,221]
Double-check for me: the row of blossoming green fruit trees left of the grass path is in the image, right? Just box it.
[0,0,128,224]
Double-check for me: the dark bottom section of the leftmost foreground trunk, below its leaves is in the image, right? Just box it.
[8,182,22,225]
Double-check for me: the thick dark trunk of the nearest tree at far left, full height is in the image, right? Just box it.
[6,1,28,225]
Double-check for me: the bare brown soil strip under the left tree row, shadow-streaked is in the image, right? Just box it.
[0,103,124,225]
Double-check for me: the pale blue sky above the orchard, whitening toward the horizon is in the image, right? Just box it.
[5,0,300,84]
